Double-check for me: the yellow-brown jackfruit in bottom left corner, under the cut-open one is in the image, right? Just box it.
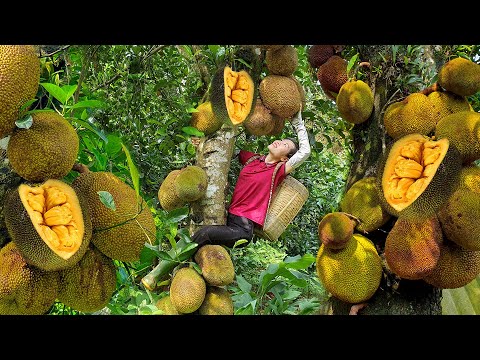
[0,241,59,315]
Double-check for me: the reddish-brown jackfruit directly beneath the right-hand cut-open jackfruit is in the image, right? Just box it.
[385,216,443,280]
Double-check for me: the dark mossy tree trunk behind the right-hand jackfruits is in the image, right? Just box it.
[331,46,442,315]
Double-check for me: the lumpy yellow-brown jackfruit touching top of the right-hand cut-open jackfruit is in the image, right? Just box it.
[383,92,437,140]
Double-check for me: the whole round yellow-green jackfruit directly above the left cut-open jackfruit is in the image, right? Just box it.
[7,111,80,182]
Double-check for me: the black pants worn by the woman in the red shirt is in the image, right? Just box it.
[192,213,254,248]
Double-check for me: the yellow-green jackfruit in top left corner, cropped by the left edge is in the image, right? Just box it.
[0,45,40,139]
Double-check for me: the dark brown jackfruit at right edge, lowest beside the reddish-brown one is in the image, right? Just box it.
[423,237,480,289]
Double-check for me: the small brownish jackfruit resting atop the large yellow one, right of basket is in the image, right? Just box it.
[317,212,356,249]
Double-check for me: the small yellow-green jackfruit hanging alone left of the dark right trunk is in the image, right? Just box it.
[337,80,373,124]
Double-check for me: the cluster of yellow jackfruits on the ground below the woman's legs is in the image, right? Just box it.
[156,245,235,315]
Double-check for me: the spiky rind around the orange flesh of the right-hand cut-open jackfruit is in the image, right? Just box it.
[376,134,462,220]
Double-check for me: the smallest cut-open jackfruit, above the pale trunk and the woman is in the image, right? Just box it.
[210,66,256,125]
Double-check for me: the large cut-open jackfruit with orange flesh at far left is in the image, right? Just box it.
[4,179,92,271]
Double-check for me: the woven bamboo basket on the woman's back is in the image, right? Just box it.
[255,176,308,241]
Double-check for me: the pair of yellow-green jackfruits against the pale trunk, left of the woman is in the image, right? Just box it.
[158,165,208,211]
